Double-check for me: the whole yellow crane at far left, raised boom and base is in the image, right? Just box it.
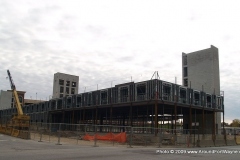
[6,70,30,139]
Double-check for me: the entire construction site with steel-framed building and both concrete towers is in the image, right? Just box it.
[0,46,236,146]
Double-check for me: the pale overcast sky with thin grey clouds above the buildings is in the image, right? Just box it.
[0,0,240,123]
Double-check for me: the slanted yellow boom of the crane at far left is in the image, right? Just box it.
[7,70,23,115]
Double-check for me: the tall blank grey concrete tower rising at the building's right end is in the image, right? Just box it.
[182,45,221,132]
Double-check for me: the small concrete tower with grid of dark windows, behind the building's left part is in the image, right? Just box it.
[52,72,79,99]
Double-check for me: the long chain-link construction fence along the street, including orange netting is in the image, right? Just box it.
[30,123,202,147]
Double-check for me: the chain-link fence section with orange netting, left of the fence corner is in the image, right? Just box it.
[30,123,131,146]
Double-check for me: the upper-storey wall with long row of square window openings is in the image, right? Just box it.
[0,80,224,117]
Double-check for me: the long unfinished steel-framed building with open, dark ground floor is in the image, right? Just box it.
[0,47,224,134]
